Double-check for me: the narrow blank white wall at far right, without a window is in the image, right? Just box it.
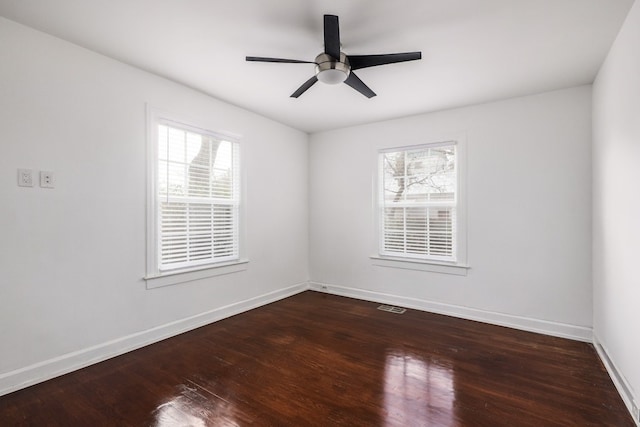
[593,2,640,414]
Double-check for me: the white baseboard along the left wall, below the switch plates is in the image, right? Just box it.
[0,282,309,396]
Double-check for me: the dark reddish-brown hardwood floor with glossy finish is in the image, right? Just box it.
[0,291,634,427]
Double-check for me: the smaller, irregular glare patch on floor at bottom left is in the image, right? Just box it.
[152,385,239,427]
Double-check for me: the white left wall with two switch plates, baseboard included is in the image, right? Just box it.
[0,18,308,394]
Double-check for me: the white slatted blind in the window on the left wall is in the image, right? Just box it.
[155,121,240,271]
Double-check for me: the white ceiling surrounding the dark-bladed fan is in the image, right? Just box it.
[0,0,633,132]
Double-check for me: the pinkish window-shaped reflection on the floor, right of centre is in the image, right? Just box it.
[384,352,456,426]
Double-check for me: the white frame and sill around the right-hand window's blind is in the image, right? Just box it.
[370,139,470,276]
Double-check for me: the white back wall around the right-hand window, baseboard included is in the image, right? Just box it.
[309,86,592,340]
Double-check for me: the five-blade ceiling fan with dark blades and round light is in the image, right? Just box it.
[246,15,422,98]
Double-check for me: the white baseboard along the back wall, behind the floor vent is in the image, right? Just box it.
[309,282,593,342]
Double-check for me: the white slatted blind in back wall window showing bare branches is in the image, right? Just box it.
[379,141,458,261]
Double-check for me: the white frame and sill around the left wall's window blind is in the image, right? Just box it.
[144,105,249,289]
